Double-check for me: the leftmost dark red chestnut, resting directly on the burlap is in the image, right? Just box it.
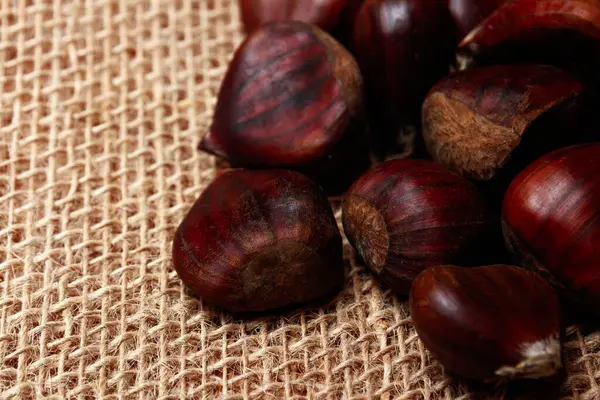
[173,170,344,312]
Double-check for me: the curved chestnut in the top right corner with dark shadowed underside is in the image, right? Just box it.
[461,0,600,88]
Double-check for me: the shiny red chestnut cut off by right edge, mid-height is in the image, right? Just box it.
[502,143,600,315]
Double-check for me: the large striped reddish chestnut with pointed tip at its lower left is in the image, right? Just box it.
[200,21,370,192]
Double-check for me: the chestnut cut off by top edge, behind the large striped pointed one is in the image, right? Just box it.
[239,0,345,32]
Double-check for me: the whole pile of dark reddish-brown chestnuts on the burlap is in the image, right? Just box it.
[173,0,600,394]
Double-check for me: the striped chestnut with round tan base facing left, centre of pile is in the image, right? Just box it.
[342,159,490,294]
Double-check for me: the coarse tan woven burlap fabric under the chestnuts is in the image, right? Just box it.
[0,0,600,400]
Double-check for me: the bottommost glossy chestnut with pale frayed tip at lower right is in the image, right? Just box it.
[410,265,562,380]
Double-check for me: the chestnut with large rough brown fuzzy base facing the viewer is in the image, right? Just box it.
[423,65,598,186]
